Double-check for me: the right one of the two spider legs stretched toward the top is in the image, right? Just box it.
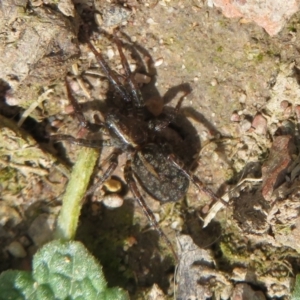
[114,36,145,108]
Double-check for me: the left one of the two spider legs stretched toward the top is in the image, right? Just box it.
[87,40,132,102]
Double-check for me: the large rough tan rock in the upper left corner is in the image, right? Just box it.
[0,1,80,105]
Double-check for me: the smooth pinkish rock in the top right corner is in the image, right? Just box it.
[213,0,300,36]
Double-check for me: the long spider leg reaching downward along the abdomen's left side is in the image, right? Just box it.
[124,160,178,261]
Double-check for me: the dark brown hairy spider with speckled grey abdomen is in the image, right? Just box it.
[51,31,222,260]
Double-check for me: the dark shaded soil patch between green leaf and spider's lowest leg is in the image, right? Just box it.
[76,198,173,295]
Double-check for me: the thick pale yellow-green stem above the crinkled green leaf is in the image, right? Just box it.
[55,147,99,240]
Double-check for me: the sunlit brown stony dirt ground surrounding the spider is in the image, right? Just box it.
[0,0,300,299]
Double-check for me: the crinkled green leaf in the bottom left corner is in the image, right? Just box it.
[0,240,129,300]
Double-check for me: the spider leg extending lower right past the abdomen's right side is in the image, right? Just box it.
[168,154,228,206]
